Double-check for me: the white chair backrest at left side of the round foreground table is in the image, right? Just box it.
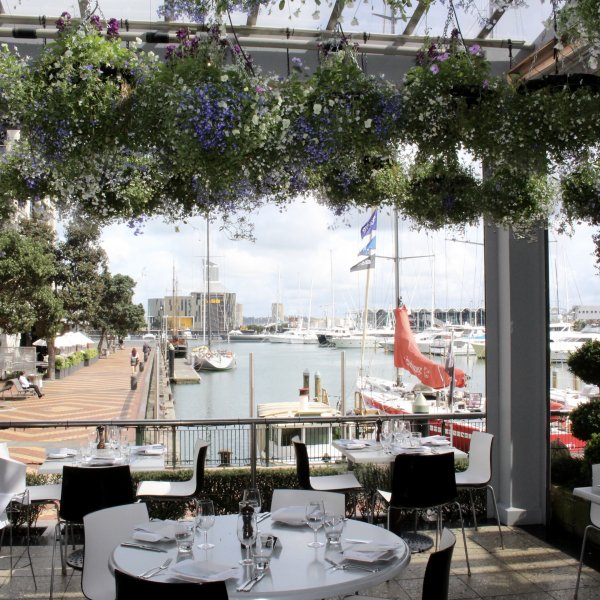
[81,502,149,600]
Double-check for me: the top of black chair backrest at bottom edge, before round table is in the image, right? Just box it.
[115,569,229,600]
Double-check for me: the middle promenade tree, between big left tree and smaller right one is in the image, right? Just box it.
[56,218,107,326]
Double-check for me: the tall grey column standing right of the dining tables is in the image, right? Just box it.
[485,226,549,525]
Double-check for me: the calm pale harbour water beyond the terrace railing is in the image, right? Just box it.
[173,342,573,419]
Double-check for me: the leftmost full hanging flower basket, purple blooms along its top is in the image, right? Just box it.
[19,13,156,166]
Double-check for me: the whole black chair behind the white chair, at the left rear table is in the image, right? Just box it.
[50,465,135,598]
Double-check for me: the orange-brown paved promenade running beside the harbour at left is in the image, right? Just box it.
[0,348,156,466]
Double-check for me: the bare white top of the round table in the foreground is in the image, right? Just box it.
[109,515,410,600]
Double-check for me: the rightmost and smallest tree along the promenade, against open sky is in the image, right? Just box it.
[91,272,145,350]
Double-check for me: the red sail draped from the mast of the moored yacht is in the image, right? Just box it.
[394,306,465,389]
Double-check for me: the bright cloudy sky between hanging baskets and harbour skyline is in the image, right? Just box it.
[103,201,600,317]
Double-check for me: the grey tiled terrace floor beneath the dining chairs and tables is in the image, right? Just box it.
[0,526,600,600]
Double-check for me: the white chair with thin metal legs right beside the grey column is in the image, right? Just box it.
[455,431,504,549]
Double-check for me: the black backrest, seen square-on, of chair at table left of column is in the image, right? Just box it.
[390,452,457,508]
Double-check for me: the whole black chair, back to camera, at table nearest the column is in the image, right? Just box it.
[377,452,471,576]
